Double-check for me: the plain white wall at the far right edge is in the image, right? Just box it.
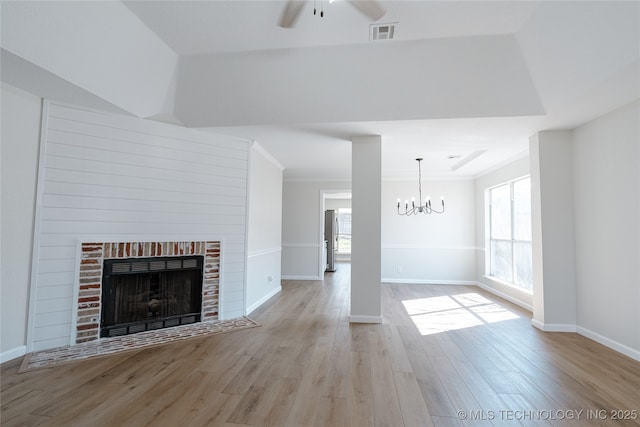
[573,101,640,360]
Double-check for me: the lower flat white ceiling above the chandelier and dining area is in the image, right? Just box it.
[209,117,536,180]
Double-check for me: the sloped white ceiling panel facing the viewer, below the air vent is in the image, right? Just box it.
[176,35,544,127]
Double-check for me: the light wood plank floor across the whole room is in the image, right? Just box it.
[1,264,640,427]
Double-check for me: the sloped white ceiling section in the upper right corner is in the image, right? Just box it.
[516,1,640,125]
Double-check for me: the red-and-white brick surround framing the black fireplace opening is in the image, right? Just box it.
[76,241,220,344]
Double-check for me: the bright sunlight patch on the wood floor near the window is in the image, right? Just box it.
[402,292,518,335]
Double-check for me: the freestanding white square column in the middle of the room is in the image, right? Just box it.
[349,135,382,323]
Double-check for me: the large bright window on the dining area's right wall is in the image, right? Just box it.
[488,177,533,290]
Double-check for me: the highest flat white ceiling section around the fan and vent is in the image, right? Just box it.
[124,0,536,55]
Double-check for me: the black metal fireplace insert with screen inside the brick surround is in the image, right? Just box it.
[100,256,203,337]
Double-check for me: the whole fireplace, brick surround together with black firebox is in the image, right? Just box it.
[74,240,221,344]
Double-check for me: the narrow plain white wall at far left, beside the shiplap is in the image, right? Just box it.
[0,83,42,363]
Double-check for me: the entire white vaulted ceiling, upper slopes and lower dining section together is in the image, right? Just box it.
[1,0,640,179]
